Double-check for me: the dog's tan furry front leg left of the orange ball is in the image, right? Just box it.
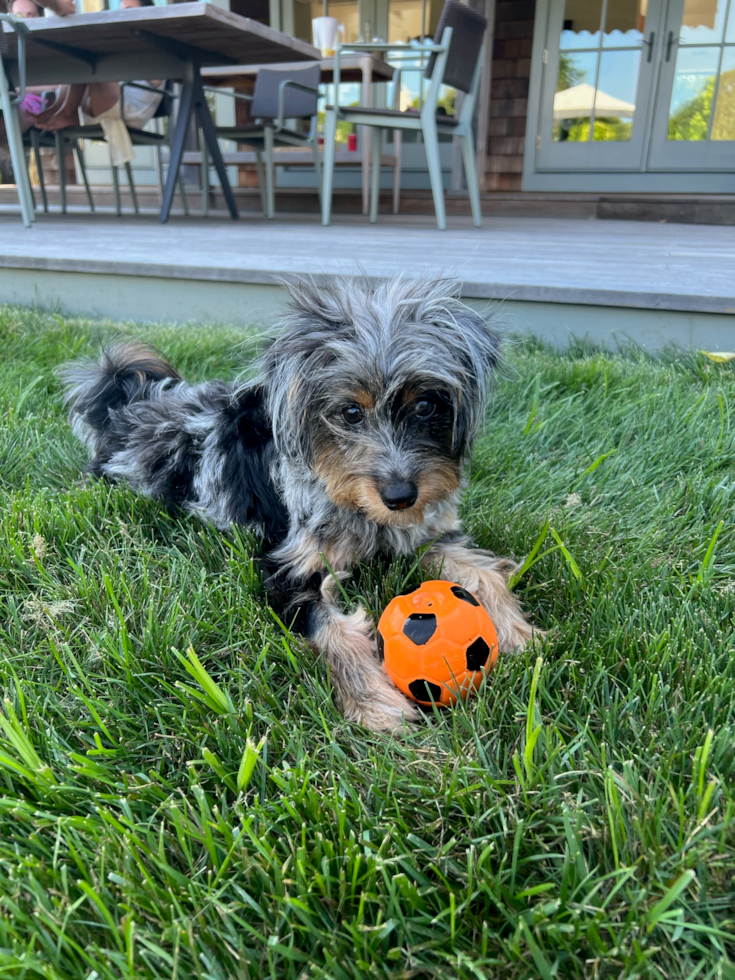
[312,575,417,732]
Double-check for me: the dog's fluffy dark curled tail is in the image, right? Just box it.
[59,341,181,451]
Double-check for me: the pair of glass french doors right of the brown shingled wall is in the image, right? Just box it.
[536,0,735,173]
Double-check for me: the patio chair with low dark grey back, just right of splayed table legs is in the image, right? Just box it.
[207,64,322,218]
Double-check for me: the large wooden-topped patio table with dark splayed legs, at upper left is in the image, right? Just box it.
[3,3,320,221]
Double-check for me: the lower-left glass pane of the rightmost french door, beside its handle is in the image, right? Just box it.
[668,48,721,140]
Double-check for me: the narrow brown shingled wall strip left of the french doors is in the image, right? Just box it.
[484,0,536,191]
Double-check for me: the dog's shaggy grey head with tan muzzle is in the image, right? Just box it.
[264,278,499,527]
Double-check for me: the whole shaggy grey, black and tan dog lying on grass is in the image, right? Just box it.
[63,278,533,731]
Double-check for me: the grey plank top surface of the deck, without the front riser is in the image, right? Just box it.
[0,213,735,313]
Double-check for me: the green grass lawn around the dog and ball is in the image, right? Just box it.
[0,308,735,980]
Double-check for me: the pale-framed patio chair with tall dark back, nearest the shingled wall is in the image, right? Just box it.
[322,0,487,231]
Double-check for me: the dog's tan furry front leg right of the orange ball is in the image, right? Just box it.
[423,538,543,653]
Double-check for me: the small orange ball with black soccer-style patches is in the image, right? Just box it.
[377,582,498,706]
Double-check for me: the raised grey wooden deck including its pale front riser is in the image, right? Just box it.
[0,207,735,349]
